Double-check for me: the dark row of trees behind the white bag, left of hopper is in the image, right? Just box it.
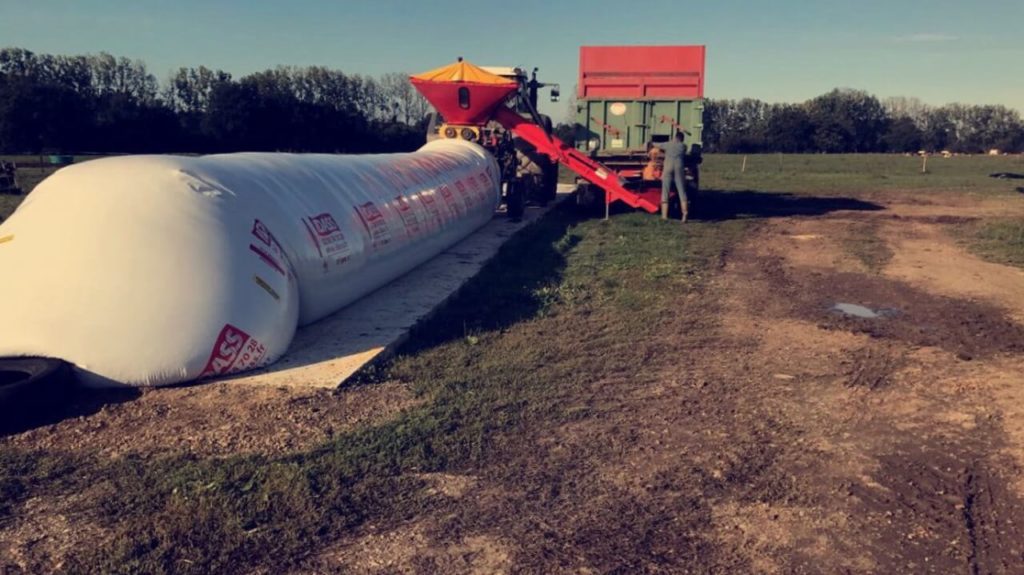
[0,48,429,153]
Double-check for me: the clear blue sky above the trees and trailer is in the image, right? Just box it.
[0,0,1024,119]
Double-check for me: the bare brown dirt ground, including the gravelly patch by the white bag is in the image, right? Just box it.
[0,188,1024,574]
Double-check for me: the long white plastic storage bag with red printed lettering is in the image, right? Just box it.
[0,140,501,386]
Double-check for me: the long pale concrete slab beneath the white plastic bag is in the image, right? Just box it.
[224,184,573,388]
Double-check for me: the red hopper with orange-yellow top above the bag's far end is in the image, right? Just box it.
[410,58,518,125]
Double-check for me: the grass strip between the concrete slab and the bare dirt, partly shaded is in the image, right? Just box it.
[0,206,749,573]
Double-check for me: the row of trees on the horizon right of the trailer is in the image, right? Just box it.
[703,89,1024,153]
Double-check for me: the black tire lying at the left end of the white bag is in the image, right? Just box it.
[0,357,72,413]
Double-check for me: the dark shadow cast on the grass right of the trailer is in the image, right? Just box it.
[694,189,885,222]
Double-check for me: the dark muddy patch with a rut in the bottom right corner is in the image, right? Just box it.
[849,437,1024,574]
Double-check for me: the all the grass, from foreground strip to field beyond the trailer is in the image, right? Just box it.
[6,151,1024,573]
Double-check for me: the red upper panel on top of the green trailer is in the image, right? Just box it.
[577,46,705,99]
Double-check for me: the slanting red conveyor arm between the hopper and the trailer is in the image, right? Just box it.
[495,106,659,214]
